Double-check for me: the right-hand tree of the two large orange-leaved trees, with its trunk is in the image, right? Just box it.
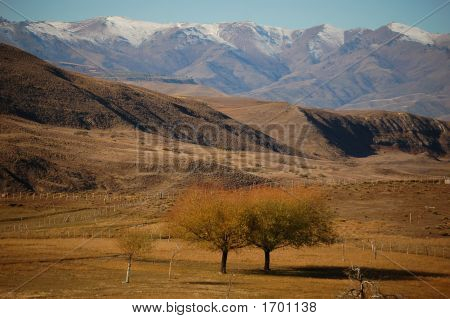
[244,188,334,272]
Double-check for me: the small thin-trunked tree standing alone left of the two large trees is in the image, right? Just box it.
[117,231,150,284]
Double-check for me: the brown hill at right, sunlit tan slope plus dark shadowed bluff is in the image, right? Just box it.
[201,97,450,158]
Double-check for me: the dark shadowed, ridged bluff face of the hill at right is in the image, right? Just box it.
[301,109,450,157]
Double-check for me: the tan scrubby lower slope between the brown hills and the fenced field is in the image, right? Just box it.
[0,111,449,194]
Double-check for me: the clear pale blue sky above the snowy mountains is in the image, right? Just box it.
[0,0,450,33]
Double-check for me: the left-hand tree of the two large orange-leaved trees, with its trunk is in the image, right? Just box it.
[171,187,247,274]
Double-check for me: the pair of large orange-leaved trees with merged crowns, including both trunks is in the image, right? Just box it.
[171,187,334,273]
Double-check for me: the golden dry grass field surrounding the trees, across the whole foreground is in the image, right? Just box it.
[0,182,450,298]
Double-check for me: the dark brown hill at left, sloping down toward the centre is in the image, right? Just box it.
[0,44,288,152]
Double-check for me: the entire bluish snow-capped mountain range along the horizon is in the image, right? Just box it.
[0,17,450,116]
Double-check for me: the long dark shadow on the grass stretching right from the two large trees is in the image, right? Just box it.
[242,266,449,280]
